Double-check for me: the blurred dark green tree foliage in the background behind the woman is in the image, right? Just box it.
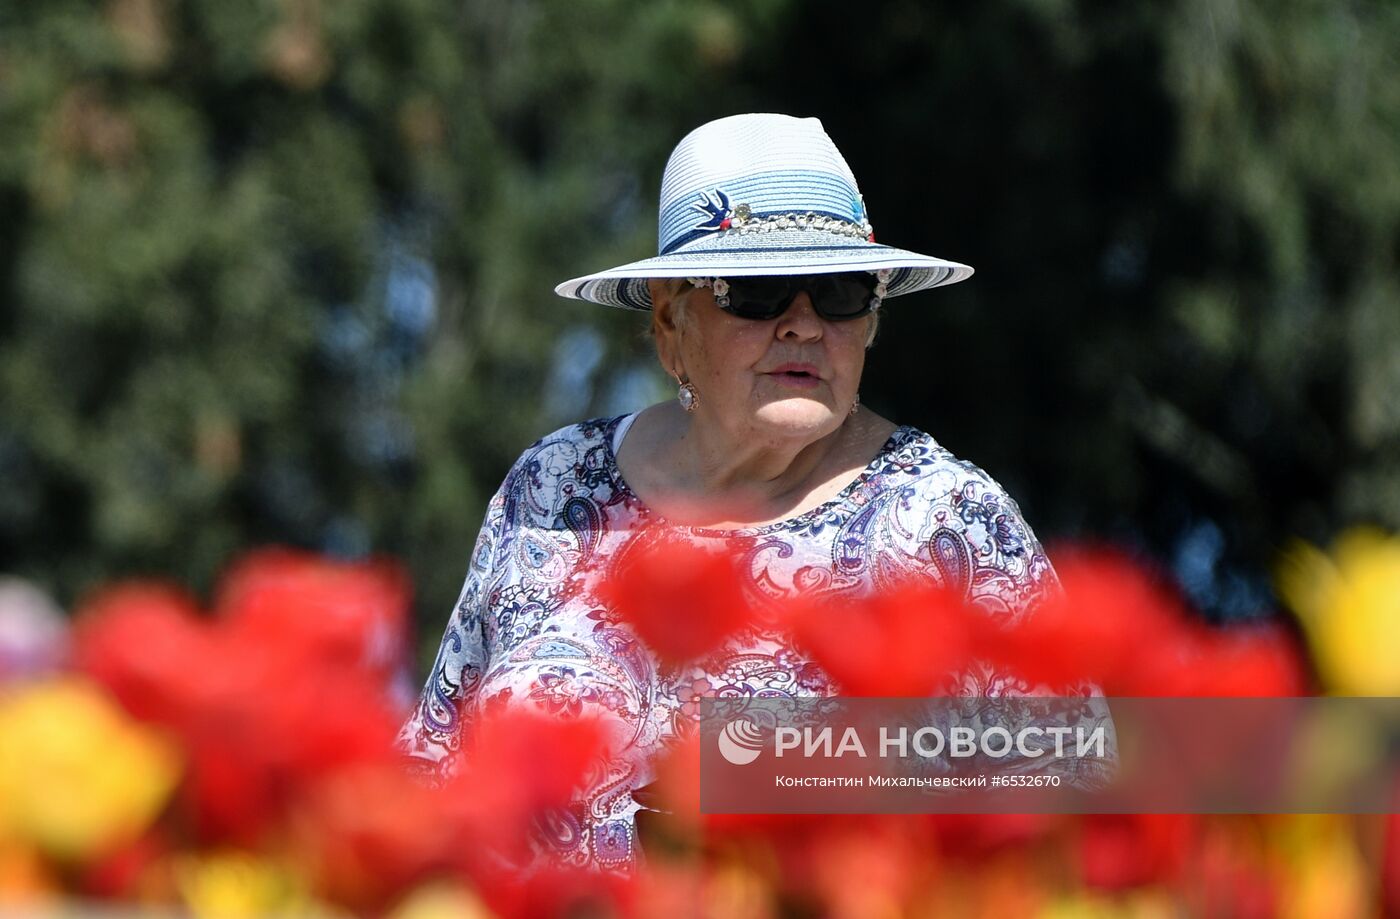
[0,0,1400,650]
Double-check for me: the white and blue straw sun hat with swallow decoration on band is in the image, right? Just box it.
[554,115,972,310]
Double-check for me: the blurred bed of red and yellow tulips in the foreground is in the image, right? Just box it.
[0,534,1400,919]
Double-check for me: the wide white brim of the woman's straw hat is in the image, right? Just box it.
[554,230,973,310]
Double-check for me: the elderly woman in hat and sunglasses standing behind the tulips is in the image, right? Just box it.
[400,115,1056,870]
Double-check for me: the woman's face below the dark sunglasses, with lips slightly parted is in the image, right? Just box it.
[651,275,874,441]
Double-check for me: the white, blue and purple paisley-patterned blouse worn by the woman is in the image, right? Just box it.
[399,415,1058,871]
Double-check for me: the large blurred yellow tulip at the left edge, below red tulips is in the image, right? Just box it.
[0,678,179,862]
